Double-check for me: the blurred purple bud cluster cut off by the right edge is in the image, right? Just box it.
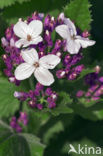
[76,66,103,102]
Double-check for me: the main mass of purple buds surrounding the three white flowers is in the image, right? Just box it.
[1,12,89,85]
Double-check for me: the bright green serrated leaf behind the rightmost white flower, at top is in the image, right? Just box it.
[64,0,92,31]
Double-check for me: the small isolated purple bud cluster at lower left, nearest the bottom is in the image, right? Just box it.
[10,112,28,133]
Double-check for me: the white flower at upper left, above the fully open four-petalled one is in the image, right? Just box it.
[13,20,43,48]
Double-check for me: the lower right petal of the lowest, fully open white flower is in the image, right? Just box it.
[34,67,54,86]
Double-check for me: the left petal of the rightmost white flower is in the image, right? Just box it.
[55,24,70,39]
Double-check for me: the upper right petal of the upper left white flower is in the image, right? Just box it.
[29,20,43,38]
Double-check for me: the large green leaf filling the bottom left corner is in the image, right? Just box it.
[0,121,45,156]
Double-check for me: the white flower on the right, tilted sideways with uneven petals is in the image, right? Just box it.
[56,18,95,54]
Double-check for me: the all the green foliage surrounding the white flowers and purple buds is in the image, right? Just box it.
[0,0,103,156]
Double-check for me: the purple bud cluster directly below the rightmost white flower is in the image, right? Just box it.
[56,53,85,80]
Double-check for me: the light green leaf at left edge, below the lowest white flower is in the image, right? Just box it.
[0,77,28,118]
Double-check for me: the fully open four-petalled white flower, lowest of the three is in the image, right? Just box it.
[15,48,60,86]
